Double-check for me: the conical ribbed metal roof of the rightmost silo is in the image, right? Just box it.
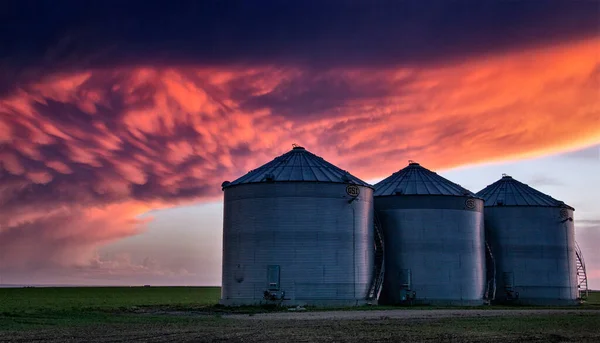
[477,174,574,210]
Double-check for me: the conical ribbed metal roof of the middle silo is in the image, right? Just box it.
[373,161,475,196]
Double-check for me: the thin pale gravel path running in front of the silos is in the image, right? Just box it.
[223,309,600,321]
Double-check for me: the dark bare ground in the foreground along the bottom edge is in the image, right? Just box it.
[0,309,600,343]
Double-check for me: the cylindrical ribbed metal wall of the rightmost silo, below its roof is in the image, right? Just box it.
[485,206,577,304]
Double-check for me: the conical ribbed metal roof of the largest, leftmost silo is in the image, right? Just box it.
[221,145,373,189]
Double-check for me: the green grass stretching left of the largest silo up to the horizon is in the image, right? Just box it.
[0,287,221,330]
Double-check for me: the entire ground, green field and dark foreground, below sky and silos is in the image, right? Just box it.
[0,287,600,342]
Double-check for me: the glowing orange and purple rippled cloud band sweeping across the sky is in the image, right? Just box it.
[0,39,600,276]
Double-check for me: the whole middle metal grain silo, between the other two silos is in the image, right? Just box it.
[374,161,485,305]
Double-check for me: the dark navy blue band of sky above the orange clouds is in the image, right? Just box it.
[0,0,600,68]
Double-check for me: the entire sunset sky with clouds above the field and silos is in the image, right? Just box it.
[0,0,600,289]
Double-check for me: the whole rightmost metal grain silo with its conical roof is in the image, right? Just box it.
[477,175,578,304]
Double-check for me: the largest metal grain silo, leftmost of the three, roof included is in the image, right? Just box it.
[221,146,374,305]
